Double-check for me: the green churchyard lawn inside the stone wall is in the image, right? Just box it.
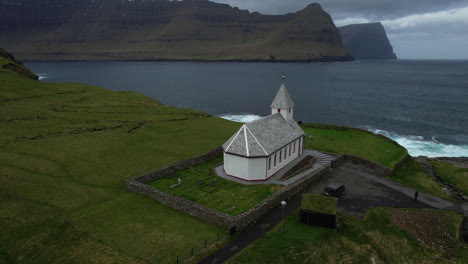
[150,157,282,215]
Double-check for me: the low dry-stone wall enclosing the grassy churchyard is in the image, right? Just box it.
[125,147,331,231]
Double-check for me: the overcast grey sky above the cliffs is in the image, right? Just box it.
[213,0,468,59]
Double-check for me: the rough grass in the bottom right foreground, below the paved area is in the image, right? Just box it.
[227,208,468,264]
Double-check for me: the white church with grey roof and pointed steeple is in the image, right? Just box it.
[223,77,305,181]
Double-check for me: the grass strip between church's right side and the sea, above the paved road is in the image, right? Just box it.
[303,124,408,168]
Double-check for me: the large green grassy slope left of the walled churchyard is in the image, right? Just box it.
[0,67,239,263]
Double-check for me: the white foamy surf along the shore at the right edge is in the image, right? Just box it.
[368,128,468,158]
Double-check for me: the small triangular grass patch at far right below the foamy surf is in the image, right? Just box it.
[389,159,456,202]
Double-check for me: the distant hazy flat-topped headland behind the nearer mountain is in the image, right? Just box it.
[339,23,397,60]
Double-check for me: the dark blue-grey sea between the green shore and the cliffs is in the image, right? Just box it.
[26,60,468,157]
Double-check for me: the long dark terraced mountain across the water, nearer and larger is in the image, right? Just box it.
[0,0,353,61]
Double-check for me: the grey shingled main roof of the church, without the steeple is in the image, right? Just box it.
[223,113,304,157]
